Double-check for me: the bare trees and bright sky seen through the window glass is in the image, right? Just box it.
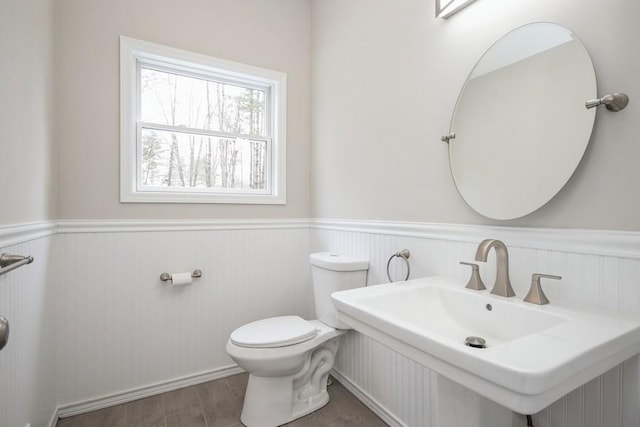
[139,66,268,190]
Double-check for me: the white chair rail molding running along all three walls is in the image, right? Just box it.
[0,218,640,259]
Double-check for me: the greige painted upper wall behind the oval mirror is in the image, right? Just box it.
[311,0,640,230]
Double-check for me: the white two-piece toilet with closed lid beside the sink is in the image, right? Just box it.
[227,252,369,427]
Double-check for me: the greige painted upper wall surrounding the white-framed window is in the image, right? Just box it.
[56,0,311,219]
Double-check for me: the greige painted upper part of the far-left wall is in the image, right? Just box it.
[0,0,56,226]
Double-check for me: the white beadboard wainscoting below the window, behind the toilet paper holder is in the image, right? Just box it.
[54,220,313,415]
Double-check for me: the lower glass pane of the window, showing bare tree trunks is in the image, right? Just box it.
[140,129,267,190]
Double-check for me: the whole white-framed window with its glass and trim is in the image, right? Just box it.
[120,37,286,204]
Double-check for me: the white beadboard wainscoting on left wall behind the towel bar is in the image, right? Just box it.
[0,223,57,427]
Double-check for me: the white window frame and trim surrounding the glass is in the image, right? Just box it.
[120,36,287,205]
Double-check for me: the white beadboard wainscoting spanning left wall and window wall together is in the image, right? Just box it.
[0,219,313,427]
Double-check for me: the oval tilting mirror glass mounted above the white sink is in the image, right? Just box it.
[449,23,596,219]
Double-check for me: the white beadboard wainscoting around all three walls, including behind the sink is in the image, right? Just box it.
[0,219,640,427]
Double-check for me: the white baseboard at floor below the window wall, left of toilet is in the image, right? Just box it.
[55,365,244,427]
